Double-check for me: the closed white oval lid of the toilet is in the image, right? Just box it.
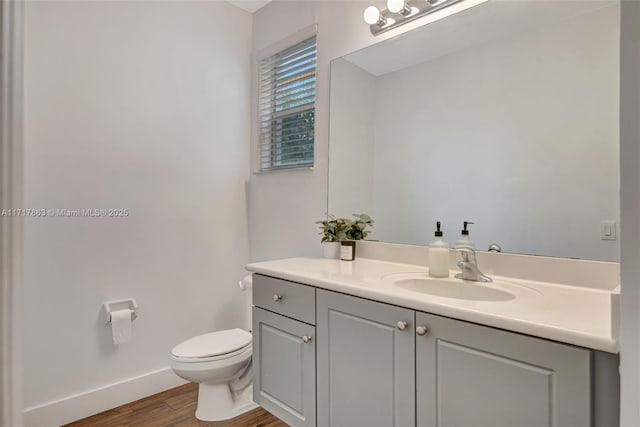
[171,329,251,358]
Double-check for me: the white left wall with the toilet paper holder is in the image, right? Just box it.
[23,1,251,424]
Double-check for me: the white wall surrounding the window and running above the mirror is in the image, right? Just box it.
[249,0,484,261]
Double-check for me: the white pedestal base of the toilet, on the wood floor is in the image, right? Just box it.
[196,383,258,421]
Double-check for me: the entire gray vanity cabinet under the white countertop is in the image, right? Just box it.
[253,275,619,427]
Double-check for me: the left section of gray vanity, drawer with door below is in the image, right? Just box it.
[252,275,316,427]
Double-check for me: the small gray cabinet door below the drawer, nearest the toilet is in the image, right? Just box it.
[253,307,316,427]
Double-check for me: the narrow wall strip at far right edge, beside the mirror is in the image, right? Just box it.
[620,0,640,427]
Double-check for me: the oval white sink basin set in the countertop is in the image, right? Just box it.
[393,277,516,301]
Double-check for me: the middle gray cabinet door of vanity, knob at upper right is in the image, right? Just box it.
[316,289,415,427]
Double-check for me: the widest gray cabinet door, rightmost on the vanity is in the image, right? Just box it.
[416,312,591,427]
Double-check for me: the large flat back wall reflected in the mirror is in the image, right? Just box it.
[370,5,620,261]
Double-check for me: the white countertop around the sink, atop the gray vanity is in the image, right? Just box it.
[246,258,618,353]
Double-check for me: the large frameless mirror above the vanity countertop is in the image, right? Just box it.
[328,0,620,261]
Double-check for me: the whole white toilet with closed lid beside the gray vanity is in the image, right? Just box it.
[171,329,258,421]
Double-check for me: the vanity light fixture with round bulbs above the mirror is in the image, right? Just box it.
[364,0,462,36]
